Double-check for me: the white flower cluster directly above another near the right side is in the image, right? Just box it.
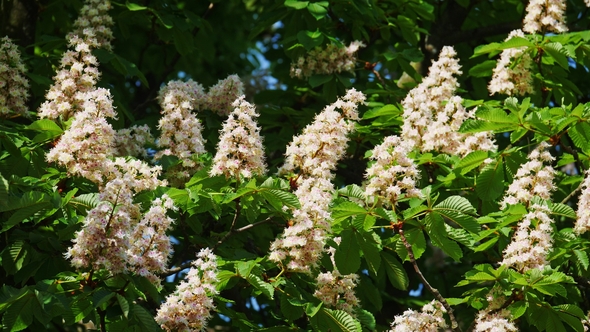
[500,142,555,209]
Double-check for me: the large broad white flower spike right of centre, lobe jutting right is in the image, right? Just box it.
[401,46,496,156]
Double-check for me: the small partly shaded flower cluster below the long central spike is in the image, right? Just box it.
[313,237,359,316]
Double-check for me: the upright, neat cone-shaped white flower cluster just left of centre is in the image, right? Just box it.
[210,95,266,178]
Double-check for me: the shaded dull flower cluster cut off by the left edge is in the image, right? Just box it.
[0,37,29,116]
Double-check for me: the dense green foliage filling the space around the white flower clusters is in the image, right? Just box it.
[0,0,590,331]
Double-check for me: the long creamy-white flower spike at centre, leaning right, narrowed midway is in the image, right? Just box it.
[269,89,365,272]
